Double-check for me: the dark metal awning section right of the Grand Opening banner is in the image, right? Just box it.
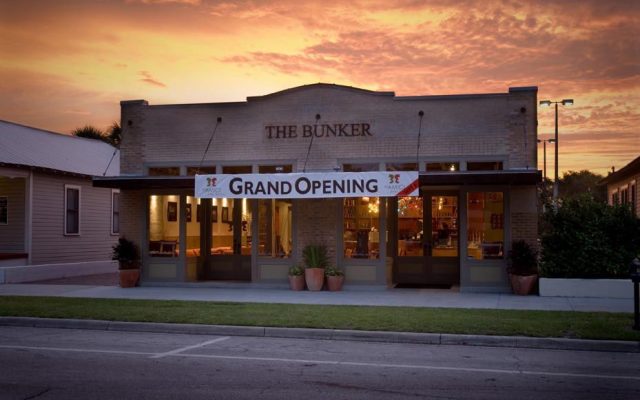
[420,170,542,186]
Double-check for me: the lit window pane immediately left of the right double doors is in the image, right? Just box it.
[342,197,380,259]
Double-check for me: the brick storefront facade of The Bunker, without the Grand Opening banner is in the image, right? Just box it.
[94,84,540,291]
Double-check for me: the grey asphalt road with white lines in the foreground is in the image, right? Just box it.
[0,327,640,400]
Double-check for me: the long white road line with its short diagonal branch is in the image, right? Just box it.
[0,342,640,381]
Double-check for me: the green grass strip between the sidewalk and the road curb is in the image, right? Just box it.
[0,296,640,341]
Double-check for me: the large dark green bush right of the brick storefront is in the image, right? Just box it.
[541,196,640,278]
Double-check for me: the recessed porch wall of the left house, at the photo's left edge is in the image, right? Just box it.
[0,176,26,253]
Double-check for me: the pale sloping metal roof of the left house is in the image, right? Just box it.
[0,120,120,176]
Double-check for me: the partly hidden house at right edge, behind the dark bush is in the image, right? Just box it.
[600,157,640,218]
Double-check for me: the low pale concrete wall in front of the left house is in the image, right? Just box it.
[0,260,118,283]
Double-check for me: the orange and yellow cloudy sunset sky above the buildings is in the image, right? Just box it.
[0,0,640,175]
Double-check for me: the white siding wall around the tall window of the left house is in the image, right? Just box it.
[32,173,117,264]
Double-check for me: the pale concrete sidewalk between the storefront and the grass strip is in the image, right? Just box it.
[0,284,633,313]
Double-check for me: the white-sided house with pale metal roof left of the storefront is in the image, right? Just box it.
[0,120,120,282]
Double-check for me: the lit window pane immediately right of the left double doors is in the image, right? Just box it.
[258,200,293,258]
